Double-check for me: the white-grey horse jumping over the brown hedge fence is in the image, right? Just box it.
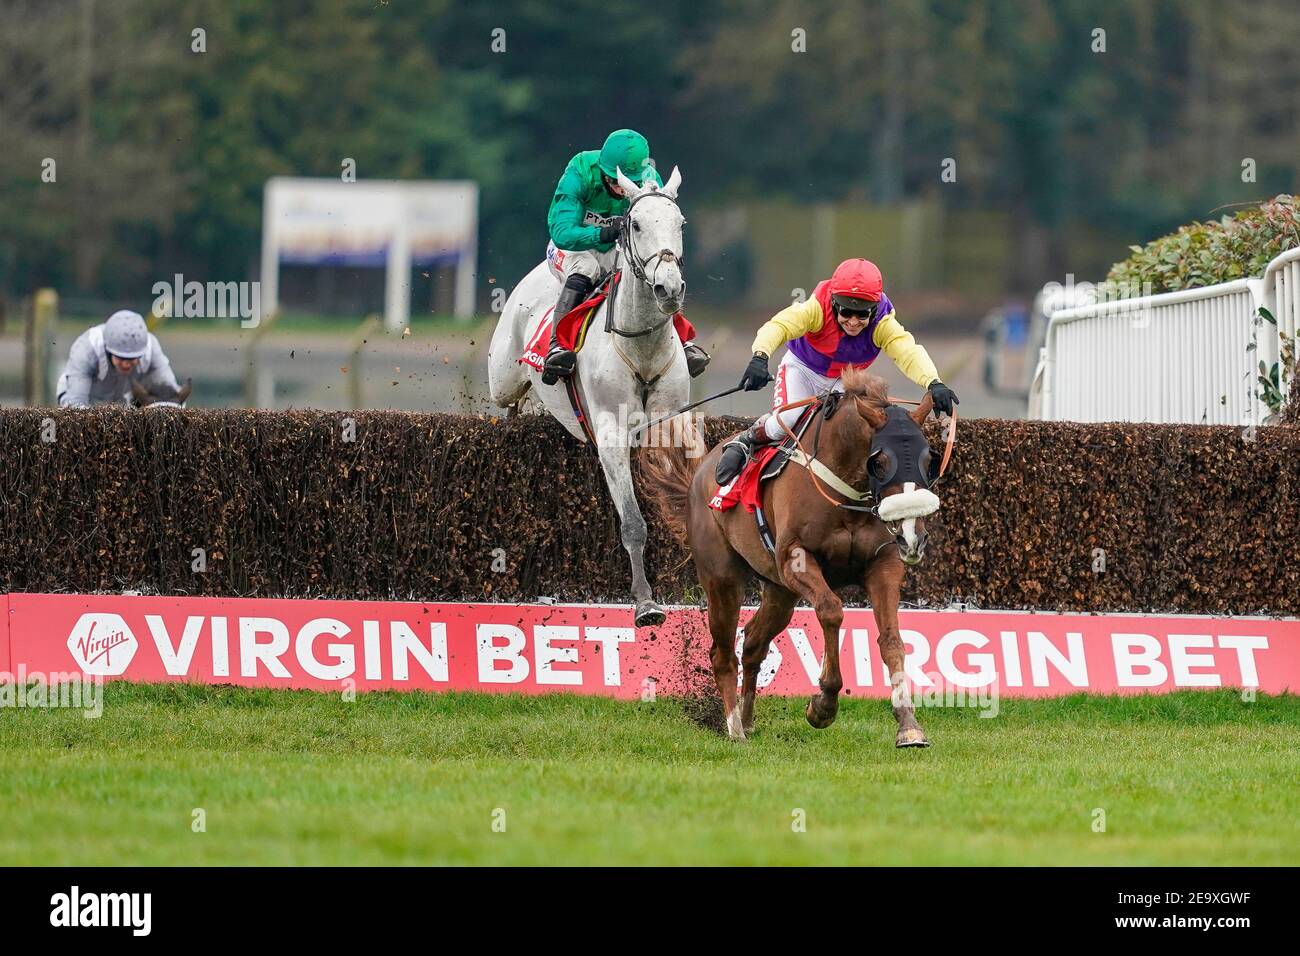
[488,168,703,627]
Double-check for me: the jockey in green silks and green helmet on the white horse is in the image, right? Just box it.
[542,130,709,385]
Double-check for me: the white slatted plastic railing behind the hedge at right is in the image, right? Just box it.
[1030,248,1300,425]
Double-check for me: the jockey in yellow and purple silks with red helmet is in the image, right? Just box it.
[715,259,957,485]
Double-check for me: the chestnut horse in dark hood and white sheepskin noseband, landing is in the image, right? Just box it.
[642,368,939,747]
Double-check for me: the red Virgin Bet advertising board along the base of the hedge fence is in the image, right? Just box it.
[0,594,1300,697]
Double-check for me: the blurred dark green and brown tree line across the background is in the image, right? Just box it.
[0,0,1300,310]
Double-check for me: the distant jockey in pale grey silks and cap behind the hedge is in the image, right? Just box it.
[57,310,181,408]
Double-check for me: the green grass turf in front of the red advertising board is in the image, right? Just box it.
[0,684,1300,865]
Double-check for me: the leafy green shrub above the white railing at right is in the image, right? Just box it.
[1106,194,1300,298]
